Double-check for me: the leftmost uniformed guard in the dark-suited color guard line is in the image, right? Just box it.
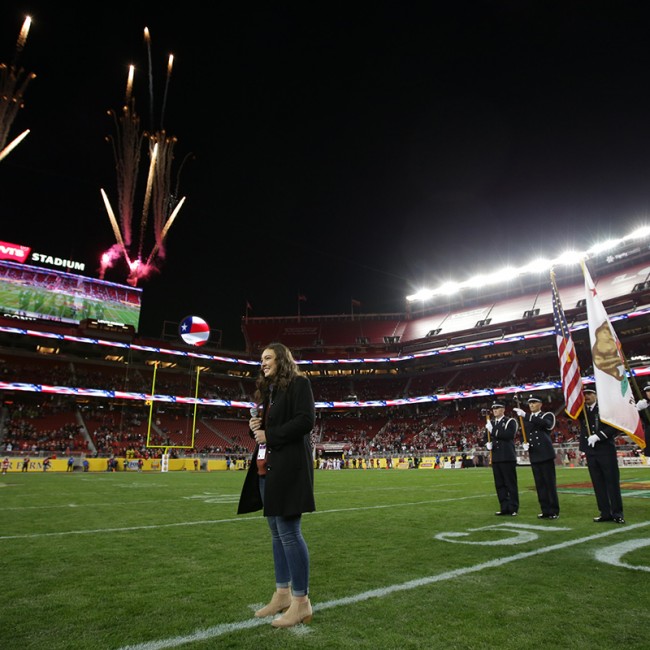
[485,402,519,517]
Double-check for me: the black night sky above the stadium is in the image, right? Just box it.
[0,0,650,350]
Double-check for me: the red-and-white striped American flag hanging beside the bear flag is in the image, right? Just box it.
[551,271,585,420]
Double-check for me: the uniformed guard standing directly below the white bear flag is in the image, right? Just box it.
[580,388,625,524]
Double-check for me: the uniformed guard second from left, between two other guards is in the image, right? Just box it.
[514,395,560,519]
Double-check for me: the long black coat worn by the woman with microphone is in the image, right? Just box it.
[237,376,316,517]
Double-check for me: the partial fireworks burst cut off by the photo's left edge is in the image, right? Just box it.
[0,16,36,160]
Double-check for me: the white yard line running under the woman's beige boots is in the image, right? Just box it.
[119,521,650,650]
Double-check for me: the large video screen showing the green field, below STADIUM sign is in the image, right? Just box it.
[0,260,142,331]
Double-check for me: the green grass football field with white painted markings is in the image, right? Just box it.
[0,467,650,650]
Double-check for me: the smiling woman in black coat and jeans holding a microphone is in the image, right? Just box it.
[237,343,316,627]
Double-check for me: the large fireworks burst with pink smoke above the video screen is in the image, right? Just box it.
[99,27,187,286]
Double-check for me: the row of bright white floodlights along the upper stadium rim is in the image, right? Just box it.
[406,226,650,302]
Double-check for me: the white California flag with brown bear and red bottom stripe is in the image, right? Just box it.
[581,262,645,449]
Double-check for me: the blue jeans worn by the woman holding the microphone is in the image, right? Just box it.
[259,476,309,596]
